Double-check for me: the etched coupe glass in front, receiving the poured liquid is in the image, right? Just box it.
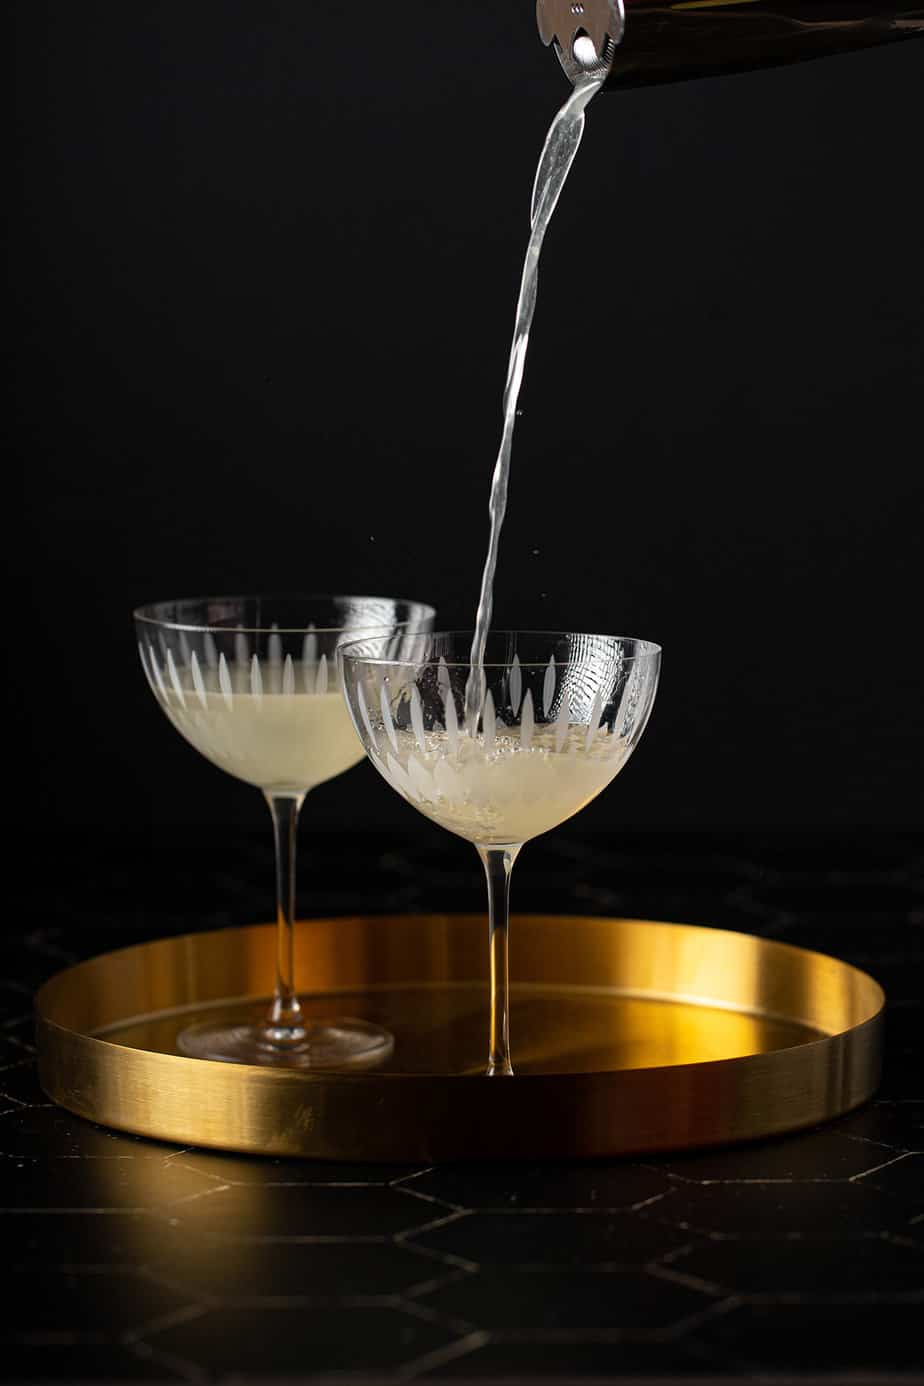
[338,631,661,1074]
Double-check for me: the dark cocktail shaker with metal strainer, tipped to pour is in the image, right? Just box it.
[536,0,924,90]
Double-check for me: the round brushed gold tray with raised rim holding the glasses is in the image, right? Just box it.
[36,915,885,1161]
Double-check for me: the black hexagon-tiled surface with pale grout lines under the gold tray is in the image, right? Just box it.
[0,834,924,1383]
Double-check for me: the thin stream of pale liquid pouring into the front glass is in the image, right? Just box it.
[465,72,605,736]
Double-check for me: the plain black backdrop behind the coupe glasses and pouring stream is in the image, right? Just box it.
[4,0,924,832]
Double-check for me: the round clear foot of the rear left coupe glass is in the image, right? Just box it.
[176,1020,395,1069]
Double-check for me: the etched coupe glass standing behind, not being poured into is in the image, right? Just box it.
[134,596,434,1069]
